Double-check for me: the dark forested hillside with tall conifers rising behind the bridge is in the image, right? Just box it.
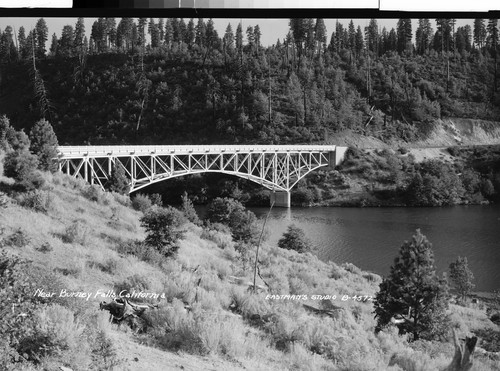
[0,18,500,144]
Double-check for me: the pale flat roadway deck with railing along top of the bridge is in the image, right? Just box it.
[58,145,336,158]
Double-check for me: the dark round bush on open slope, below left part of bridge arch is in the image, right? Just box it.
[140,207,184,257]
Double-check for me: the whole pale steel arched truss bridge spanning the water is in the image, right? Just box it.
[57,145,347,207]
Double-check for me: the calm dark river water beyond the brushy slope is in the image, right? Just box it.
[251,205,500,291]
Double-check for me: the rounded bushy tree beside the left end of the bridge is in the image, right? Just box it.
[29,119,58,172]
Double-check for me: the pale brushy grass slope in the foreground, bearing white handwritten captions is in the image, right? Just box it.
[0,174,498,371]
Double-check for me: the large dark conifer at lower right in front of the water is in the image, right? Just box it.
[374,230,448,341]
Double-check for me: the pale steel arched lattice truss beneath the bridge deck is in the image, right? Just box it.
[58,151,330,192]
